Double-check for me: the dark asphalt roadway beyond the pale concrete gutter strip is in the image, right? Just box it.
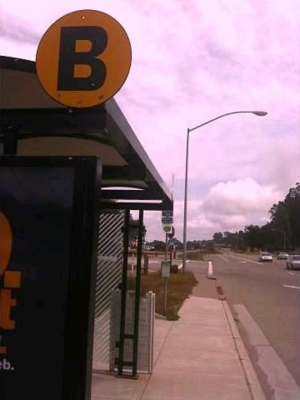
[207,251,300,398]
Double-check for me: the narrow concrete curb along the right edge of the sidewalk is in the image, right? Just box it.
[222,301,266,400]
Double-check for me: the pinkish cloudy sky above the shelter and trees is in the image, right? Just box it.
[0,0,300,241]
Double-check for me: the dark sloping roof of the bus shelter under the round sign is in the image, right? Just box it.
[0,56,173,210]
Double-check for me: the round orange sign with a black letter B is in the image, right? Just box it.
[36,10,131,108]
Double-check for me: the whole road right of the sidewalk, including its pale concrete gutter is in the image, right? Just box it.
[139,251,300,400]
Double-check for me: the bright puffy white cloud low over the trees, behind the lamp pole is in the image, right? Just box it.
[146,178,284,240]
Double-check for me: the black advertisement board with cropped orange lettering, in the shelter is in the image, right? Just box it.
[0,156,101,400]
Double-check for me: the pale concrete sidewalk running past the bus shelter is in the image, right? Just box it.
[92,268,265,400]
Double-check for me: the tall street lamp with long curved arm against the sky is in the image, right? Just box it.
[182,111,268,272]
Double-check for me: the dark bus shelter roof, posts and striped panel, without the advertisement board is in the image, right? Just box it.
[0,57,173,398]
